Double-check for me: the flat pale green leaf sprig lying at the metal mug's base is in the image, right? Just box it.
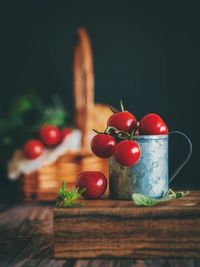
[132,189,190,206]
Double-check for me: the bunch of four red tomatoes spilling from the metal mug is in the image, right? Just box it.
[91,103,168,167]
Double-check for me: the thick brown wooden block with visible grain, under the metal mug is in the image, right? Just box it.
[54,191,200,259]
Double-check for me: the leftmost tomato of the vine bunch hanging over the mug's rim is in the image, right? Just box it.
[90,134,116,158]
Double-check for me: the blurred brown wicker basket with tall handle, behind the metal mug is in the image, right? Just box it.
[22,29,111,201]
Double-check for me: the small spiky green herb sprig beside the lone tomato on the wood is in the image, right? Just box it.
[56,181,85,208]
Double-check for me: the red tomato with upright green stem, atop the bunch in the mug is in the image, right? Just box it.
[107,111,137,133]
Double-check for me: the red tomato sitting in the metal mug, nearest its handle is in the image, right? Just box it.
[139,113,169,135]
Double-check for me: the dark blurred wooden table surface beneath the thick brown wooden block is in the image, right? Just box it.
[0,204,200,267]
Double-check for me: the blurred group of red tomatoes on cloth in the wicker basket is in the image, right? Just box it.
[23,125,72,160]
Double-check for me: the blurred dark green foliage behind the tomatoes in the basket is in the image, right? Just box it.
[0,91,69,176]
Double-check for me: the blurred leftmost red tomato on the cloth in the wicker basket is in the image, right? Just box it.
[23,139,44,159]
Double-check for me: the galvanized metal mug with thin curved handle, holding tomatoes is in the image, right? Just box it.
[109,131,192,199]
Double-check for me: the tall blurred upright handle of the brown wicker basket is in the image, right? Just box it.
[73,28,94,148]
